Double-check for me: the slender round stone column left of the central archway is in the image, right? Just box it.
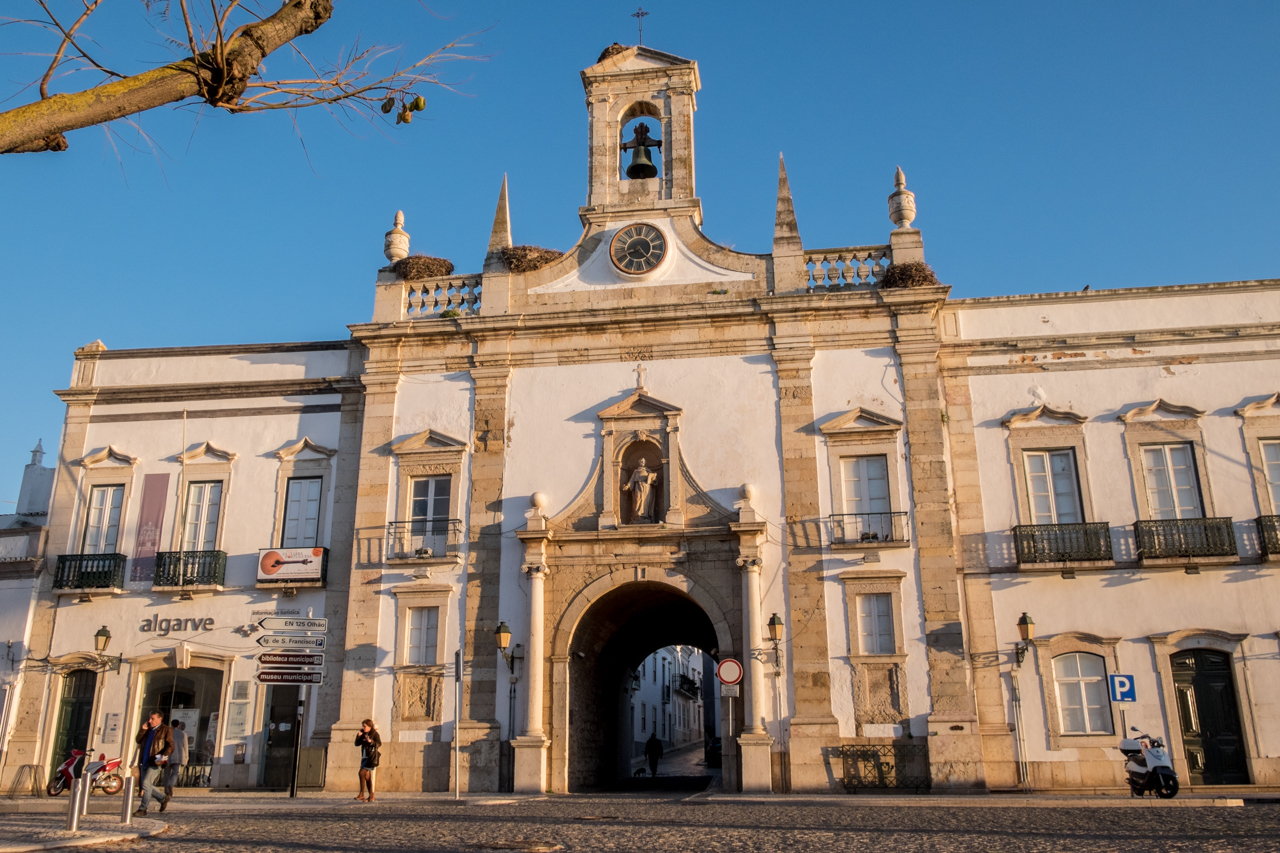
[511,510,550,794]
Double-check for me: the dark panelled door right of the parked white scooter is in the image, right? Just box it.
[1170,648,1249,785]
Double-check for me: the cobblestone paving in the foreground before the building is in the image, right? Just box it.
[112,794,1280,853]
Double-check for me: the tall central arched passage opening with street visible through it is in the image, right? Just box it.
[566,581,719,792]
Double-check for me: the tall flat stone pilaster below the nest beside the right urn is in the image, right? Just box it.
[879,289,986,789]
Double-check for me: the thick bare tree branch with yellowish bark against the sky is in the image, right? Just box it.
[0,0,333,154]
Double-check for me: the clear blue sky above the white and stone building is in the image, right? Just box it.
[0,0,1280,502]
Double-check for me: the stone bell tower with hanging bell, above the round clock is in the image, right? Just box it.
[580,45,703,225]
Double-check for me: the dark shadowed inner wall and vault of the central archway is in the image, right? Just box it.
[567,580,719,792]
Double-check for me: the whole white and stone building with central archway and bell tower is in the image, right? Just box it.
[3,47,1280,792]
